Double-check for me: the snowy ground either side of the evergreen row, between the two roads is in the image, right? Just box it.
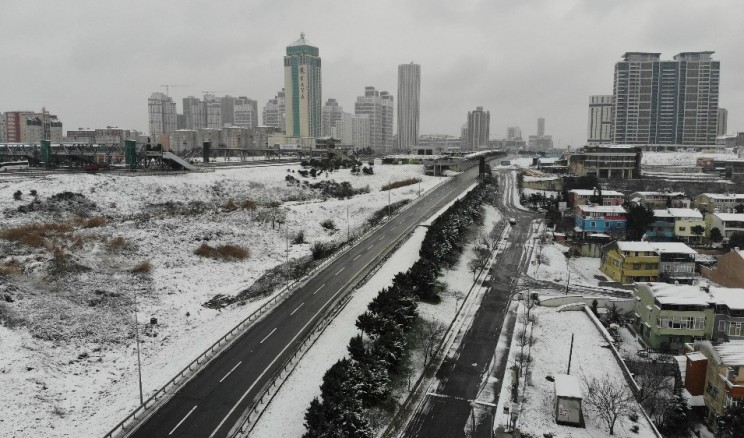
[251,206,500,438]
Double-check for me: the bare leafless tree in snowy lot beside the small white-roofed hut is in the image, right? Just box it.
[584,376,635,435]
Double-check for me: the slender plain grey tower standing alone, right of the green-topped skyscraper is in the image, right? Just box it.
[398,63,421,149]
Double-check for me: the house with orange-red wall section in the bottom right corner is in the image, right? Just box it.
[685,340,744,427]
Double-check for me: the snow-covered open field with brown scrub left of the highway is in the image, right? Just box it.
[0,165,443,436]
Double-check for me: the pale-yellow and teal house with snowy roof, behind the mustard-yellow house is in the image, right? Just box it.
[646,208,706,243]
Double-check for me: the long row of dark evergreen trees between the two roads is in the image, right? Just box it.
[303,181,494,438]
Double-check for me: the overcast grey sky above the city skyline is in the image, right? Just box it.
[0,0,744,146]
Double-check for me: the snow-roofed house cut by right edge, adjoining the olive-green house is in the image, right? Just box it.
[709,286,744,341]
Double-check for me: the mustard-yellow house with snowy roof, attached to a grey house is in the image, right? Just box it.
[599,242,660,284]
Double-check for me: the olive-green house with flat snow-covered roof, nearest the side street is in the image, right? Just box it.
[633,282,714,352]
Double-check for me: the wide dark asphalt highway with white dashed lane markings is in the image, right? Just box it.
[129,162,492,438]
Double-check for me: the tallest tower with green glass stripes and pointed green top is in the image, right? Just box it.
[284,33,322,138]
